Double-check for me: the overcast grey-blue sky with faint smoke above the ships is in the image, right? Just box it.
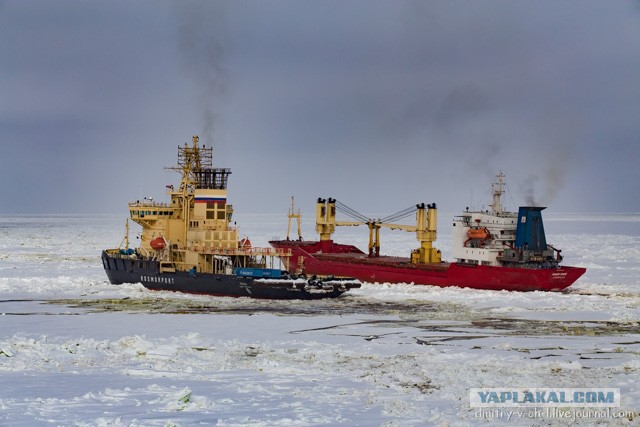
[0,0,640,217]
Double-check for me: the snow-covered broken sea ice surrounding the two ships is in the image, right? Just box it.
[0,211,640,426]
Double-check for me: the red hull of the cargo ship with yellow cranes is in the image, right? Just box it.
[269,240,586,291]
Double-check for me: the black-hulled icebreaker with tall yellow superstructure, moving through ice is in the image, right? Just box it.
[102,136,360,300]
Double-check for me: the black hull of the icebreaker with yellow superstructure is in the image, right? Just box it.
[102,251,360,300]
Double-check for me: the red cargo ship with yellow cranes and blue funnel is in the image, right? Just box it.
[269,173,586,291]
